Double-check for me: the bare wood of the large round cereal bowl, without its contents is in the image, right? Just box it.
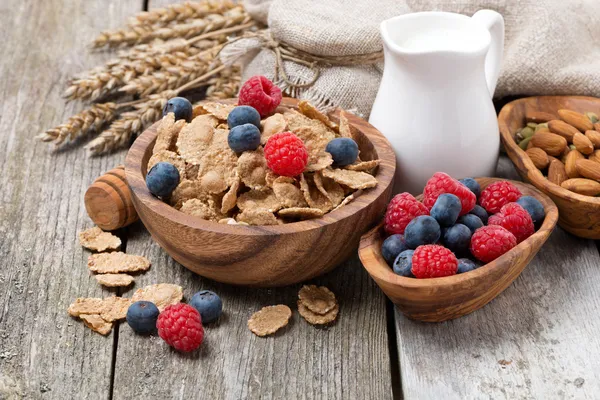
[125,98,396,286]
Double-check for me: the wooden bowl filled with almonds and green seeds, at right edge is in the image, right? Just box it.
[498,96,600,239]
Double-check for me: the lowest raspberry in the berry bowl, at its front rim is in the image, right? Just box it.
[412,244,458,279]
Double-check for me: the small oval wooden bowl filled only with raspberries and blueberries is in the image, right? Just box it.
[359,172,558,322]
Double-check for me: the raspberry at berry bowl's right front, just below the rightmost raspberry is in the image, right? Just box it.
[471,225,517,263]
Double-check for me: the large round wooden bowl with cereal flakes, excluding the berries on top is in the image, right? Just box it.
[125,98,396,287]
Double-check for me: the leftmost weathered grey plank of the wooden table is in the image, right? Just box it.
[0,0,141,399]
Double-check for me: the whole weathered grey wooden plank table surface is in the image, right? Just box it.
[0,0,600,399]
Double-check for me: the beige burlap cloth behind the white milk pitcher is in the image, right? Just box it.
[225,0,600,117]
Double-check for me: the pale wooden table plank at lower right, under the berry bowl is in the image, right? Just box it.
[396,157,600,400]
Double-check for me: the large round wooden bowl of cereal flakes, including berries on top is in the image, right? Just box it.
[125,77,396,287]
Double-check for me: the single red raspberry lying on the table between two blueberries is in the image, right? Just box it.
[156,303,204,352]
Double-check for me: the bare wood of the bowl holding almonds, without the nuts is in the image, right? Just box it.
[498,96,600,239]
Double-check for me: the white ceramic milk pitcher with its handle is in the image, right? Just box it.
[369,10,504,194]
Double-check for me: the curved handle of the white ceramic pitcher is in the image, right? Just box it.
[472,10,504,97]
